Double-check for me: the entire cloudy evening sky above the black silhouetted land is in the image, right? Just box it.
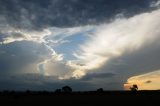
[0,0,160,91]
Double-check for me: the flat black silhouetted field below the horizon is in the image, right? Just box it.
[0,91,160,106]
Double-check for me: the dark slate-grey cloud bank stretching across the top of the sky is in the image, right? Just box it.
[0,0,157,29]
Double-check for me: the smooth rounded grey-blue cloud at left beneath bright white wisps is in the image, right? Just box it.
[0,41,50,77]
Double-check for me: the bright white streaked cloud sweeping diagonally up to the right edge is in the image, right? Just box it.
[68,9,160,78]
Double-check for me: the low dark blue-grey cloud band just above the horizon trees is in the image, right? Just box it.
[0,73,115,91]
